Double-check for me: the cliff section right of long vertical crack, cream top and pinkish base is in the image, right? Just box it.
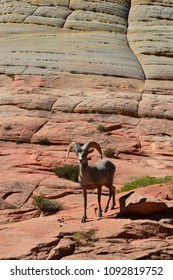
[127,0,173,119]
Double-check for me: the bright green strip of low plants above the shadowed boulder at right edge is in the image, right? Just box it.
[120,176,173,192]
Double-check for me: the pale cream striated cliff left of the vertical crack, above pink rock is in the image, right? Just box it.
[0,0,144,79]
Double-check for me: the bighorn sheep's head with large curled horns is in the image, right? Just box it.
[66,141,103,163]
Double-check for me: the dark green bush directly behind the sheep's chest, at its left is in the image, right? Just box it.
[53,165,79,182]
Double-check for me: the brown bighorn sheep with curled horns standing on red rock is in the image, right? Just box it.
[66,141,115,223]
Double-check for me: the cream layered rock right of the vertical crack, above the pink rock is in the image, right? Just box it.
[128,0,173,80]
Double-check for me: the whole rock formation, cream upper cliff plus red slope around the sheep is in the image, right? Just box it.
[0,0,173,259]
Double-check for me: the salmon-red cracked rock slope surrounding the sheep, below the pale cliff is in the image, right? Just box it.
[0,75,173,259]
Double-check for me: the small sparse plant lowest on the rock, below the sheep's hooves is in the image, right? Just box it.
[72,229,97,246]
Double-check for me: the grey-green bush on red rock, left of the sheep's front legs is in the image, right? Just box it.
[32,193,63,214]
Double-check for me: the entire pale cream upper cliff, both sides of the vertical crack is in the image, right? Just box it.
[0,0,173,80]
